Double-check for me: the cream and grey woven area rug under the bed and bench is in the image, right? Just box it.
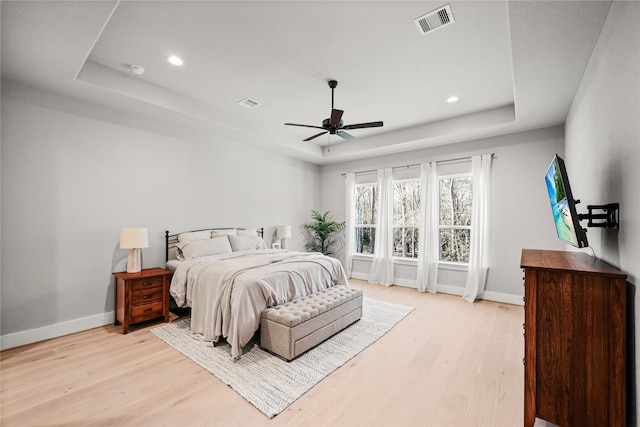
[151,298,413,418]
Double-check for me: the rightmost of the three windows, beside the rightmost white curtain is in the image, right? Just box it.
[438,175,472,264]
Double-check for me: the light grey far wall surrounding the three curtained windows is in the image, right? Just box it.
[320,127,564,304]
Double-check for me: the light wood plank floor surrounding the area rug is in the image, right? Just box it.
[0,280,524,427]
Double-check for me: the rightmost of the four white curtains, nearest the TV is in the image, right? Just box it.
[462,154,491,302]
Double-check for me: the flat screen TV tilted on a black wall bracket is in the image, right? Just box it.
[545,154,589,248]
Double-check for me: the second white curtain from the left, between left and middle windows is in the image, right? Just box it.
[369,168,393,286]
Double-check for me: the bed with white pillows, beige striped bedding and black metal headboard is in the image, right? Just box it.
[165,228,348,359]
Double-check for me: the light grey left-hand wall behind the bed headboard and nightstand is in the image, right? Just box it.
[1,81,319,347]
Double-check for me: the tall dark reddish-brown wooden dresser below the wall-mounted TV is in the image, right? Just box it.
[520,249,627,427]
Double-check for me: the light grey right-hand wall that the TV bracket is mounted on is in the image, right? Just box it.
[565,1,640,425]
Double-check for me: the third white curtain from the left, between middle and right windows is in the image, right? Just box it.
[417,162,439,292]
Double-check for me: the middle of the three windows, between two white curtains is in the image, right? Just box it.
[393,180,420,258]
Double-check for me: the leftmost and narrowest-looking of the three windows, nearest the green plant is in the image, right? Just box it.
[355,184,378,255]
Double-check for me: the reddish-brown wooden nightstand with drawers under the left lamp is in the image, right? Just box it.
[113,268,171,334]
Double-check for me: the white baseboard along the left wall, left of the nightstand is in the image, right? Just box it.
[0,311,115,350]
